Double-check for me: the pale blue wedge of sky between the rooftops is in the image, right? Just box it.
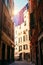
[14,0,28,15]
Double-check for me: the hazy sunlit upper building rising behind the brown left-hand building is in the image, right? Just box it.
[2,0,14,18]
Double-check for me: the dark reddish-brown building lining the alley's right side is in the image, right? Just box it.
[29,0,43,65]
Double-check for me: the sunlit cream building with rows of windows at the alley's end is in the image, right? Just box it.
[15,9,30,60]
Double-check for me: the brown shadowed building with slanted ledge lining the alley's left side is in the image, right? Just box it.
[0,0,14,64]
